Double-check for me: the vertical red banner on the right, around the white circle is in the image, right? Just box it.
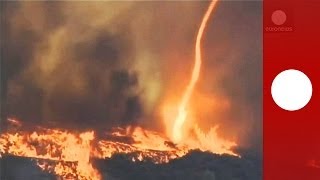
[263,0,320,180]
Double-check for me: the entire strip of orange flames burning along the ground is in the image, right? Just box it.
[0,119,237,180]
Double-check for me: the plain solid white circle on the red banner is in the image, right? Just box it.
[271,69,312,111]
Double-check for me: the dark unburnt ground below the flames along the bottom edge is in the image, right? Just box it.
[0,151,262,180]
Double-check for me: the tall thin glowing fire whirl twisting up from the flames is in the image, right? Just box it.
[173,0,217,142]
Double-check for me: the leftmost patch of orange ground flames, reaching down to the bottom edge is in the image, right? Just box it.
[0,126,100,180]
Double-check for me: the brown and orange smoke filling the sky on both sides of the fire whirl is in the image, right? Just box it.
[1,1,262,154]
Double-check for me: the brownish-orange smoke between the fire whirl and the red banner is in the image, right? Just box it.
[200,1,262,153]
